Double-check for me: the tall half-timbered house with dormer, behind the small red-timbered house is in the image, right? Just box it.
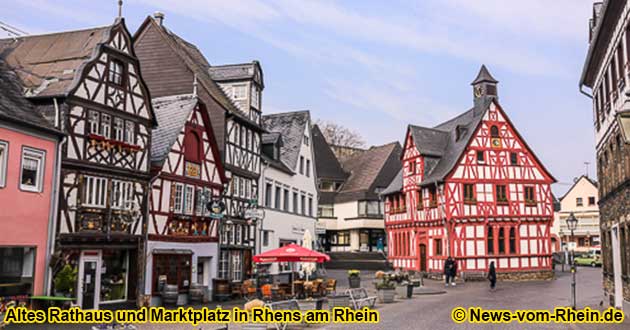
[134,13,264,283]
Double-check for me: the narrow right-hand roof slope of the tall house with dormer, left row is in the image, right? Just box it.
[133,16,259,127]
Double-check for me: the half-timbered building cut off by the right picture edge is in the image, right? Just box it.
[580,0,630,309]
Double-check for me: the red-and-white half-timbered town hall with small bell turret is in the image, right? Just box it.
[381,66,555,279]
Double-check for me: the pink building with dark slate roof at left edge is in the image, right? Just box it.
[0,59,63,301]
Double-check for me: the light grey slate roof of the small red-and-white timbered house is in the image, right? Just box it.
[151,94,199,167]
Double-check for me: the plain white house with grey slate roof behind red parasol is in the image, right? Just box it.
[256,111,318,275]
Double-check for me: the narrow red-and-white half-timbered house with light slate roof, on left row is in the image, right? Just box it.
[145,94,227,305]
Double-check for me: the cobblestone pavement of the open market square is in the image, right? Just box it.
[7,268,630,330]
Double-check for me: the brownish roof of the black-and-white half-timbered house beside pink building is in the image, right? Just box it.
[0,22,110,97]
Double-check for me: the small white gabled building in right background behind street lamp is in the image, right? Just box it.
[552,175,600,252]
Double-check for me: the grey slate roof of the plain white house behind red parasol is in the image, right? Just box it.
[262,111,310,171]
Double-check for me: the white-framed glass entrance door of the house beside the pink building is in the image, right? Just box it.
[77,251,101,309]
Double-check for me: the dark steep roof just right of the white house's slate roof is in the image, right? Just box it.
[311,125,348,181]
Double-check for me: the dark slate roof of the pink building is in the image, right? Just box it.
[0,59,63,135]
